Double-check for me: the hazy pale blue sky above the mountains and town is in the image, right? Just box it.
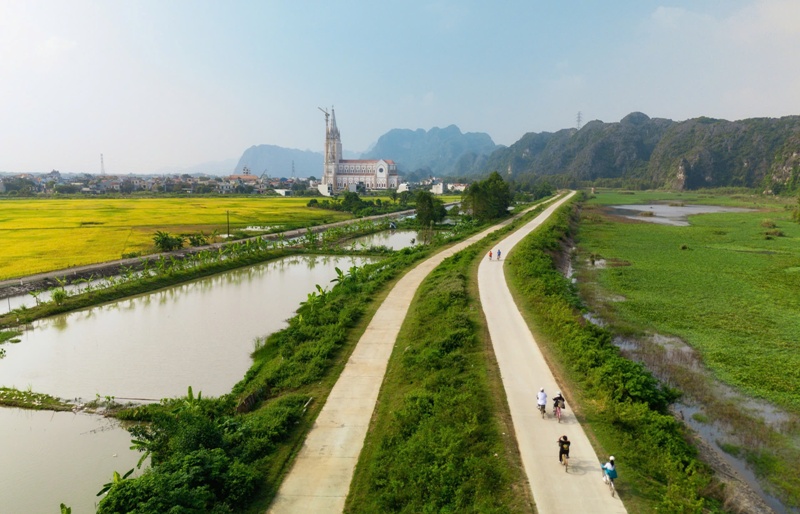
[0,0,800,173]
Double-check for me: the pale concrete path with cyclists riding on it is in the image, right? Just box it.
[478,191,626,514]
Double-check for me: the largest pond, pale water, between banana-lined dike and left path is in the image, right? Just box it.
[0,256,371,401]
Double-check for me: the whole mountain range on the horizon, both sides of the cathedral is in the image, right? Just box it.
[228,112,800,192]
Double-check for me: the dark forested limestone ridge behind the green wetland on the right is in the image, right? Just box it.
[476,112,800,192]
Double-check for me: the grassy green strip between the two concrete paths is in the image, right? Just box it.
[345,243,533,513]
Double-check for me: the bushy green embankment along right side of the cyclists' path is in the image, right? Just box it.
[506,193,718,513]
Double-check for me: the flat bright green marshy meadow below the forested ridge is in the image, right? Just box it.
[578,193,800,506]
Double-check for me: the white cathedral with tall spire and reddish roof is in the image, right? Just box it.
[319,108,400,196]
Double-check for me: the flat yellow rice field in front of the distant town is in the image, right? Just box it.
[0,197,351,280]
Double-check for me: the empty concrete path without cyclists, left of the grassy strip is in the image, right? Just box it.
[269,198,552,514]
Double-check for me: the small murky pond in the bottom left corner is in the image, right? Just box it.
[0,408,144,514]
